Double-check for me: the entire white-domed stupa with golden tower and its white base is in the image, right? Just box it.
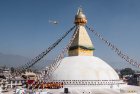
[46,8,140,94]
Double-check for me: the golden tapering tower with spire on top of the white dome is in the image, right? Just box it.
[68,8,94,56]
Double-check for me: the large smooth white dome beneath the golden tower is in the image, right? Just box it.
[52,56,119,80]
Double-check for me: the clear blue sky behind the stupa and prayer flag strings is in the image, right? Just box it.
[0,0,140,70]
